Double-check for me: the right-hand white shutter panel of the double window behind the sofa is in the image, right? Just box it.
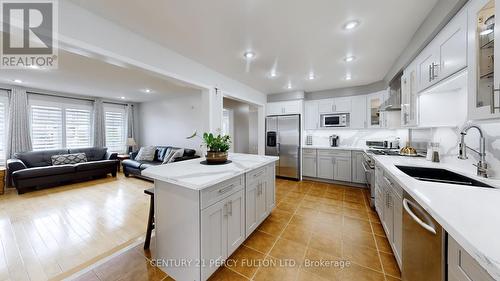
[65,108,92,148]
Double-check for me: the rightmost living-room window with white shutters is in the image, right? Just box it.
[105,109,126,153]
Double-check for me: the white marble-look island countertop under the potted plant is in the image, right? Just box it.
[142,153,279,190]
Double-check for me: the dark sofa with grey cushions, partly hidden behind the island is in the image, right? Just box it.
[122,146,200,180]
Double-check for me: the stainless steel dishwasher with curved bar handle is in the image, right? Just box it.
[402,192,446,281]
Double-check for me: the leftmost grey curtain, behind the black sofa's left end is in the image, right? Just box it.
[5,88,33,159]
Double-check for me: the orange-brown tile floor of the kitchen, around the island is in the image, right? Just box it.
[69,180,401,281]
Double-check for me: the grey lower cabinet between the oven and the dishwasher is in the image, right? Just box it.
[375,163,403,268]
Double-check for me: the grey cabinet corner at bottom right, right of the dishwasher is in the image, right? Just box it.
[448,235,495,281]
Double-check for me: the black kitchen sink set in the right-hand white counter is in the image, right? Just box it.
[396,166,495,188]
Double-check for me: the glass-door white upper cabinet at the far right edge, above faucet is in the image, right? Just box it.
[467,0,500,120]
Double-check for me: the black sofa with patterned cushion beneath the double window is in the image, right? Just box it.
[7,147,120,194]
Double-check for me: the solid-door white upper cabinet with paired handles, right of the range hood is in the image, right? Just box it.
[416,9,467,91]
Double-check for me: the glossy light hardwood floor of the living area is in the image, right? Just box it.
[0,174,152,281]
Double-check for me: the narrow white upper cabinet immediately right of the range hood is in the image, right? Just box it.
[401,63,418,127]
